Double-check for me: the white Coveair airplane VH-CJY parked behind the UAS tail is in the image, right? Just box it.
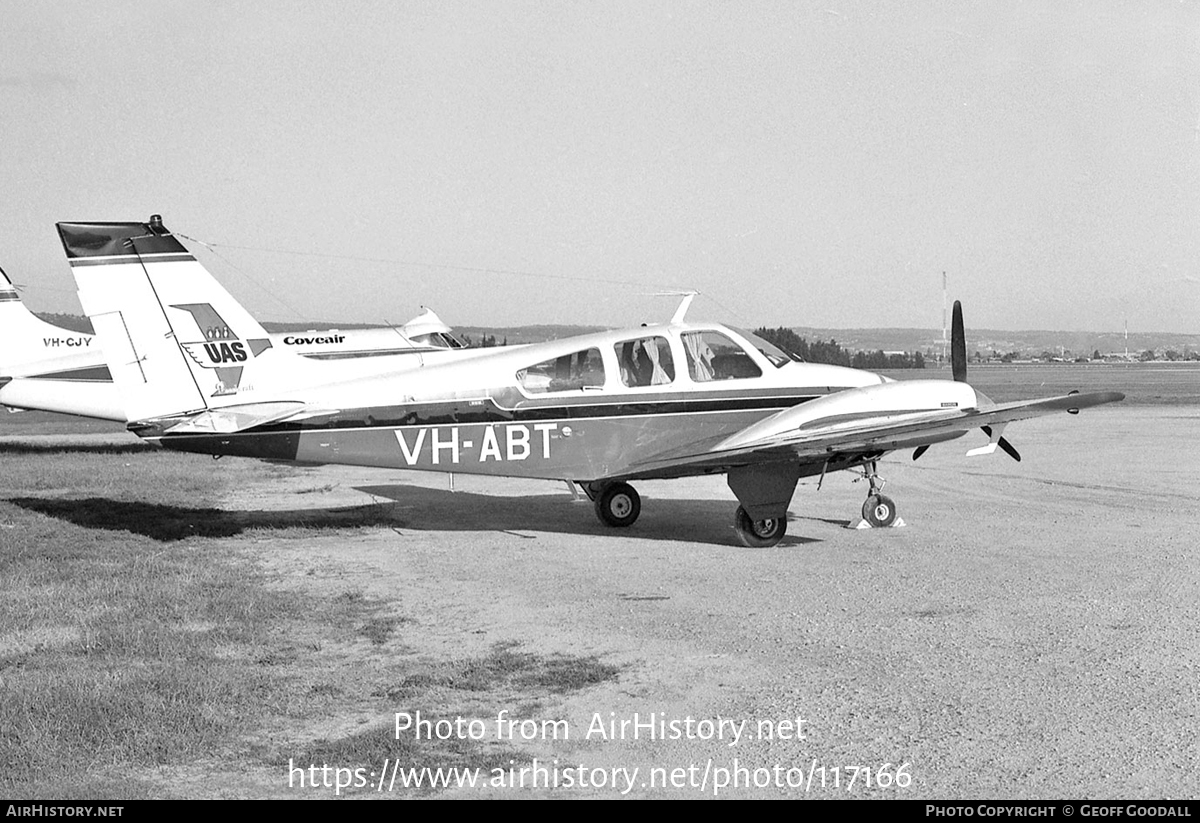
[0,261,463,422]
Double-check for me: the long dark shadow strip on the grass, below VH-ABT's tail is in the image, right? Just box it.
[6,497,402,542]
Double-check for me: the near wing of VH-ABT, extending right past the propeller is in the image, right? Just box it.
[628,391,1124,477]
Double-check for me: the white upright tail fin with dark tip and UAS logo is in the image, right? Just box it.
[58,215,300,422]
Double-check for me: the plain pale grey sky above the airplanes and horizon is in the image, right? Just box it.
[0,0,1200,332]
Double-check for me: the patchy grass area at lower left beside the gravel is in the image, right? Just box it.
[0,441,618,799]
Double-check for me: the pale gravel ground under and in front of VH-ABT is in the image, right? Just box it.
[189,407,1200,798]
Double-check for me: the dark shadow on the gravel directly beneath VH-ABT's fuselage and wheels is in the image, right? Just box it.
[354,483,821,551]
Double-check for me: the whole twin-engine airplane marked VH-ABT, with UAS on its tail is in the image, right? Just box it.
[58,216,1123,547]
